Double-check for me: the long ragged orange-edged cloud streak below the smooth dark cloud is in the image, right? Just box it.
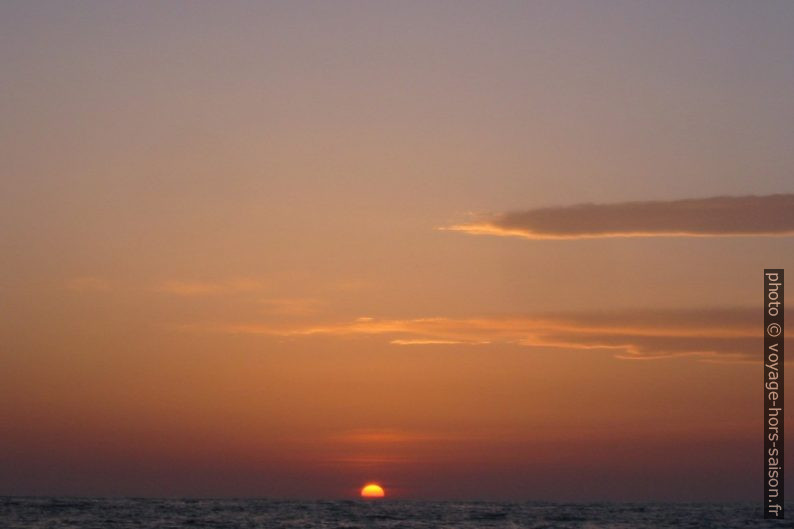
[176,308,776,360]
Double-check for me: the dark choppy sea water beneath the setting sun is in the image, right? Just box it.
[0,497,794,529]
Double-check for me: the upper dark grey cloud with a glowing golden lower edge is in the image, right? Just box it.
[442,193,794,239]
